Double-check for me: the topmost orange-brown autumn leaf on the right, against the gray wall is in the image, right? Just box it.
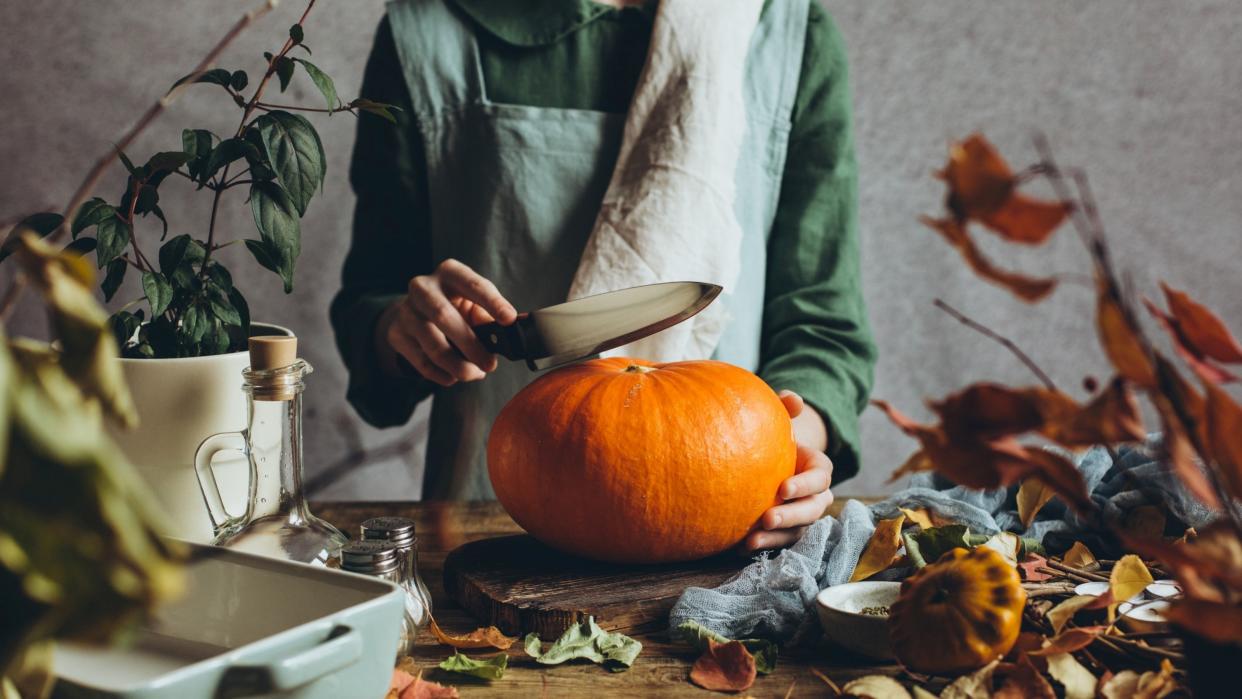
[941,134,1069,245]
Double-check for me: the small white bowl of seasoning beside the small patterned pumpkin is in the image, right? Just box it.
[815,581,902,661]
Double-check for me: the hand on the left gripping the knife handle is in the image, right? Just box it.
[375,259,518,386]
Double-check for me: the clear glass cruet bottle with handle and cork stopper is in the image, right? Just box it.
[195,336,349,565]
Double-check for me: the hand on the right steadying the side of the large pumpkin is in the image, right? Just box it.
[741,391,832,552]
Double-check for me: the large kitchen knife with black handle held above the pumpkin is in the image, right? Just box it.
[474,282,720,371]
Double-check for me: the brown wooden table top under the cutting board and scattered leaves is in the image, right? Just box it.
[312,502,898,698]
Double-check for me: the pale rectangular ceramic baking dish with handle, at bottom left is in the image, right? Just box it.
[53,545,404,699]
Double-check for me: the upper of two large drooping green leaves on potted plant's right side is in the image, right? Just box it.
[255,109,327,216]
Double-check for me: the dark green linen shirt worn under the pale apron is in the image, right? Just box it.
[330,0,876,483]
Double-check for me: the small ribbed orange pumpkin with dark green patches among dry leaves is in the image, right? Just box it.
[888,546,1026,674]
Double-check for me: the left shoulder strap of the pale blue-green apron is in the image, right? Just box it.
[388,0,483,125]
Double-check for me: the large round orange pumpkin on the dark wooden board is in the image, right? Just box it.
[487,358,796,562]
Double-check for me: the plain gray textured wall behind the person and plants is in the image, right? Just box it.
[0,0,1242,499]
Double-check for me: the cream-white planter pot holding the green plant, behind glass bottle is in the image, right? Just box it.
[106,323,292,543]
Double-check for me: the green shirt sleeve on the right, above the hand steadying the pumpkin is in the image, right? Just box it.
[759,1,876,483]
